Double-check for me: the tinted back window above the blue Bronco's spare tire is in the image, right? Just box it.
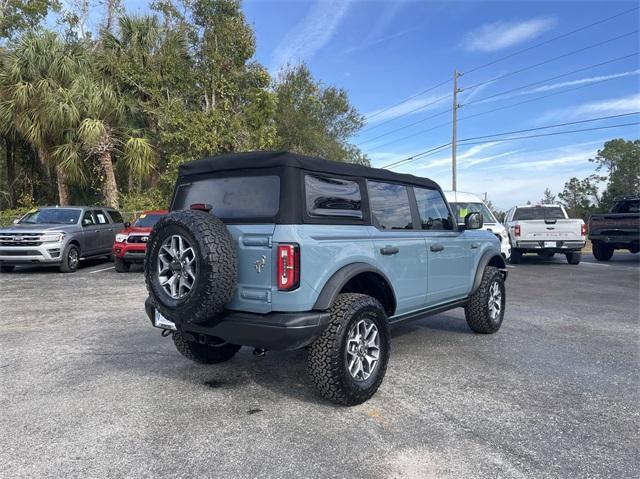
[172,175,280,219]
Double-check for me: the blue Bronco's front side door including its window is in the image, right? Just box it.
[413,188,472,306]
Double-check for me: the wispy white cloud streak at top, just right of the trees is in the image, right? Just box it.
[271,0,350,71]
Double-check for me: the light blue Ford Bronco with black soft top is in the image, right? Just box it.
[145,152,507,405]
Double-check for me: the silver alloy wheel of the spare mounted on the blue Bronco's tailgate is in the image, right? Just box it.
[158,235,197,299]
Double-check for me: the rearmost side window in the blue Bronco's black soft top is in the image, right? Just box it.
[304,175,362,219]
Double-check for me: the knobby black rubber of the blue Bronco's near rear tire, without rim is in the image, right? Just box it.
[308,293,390,406]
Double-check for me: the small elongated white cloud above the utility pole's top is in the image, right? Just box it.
[463,17,557,52]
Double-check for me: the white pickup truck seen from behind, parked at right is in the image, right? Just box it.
[505,205,587,264]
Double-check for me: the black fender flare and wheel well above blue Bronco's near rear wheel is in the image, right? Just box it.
[313,263,397,317]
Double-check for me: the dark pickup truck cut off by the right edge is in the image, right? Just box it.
[589,196,640,261]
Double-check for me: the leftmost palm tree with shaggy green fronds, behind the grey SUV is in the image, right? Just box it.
[0,31,89,205]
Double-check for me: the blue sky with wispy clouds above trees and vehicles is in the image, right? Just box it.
[119,0,640,208]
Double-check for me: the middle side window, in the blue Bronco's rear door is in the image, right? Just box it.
[367,181,413,230]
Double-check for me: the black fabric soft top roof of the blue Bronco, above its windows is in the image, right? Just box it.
[180,151,440,189]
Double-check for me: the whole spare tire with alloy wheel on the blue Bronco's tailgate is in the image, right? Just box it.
[145,210,237,323]
